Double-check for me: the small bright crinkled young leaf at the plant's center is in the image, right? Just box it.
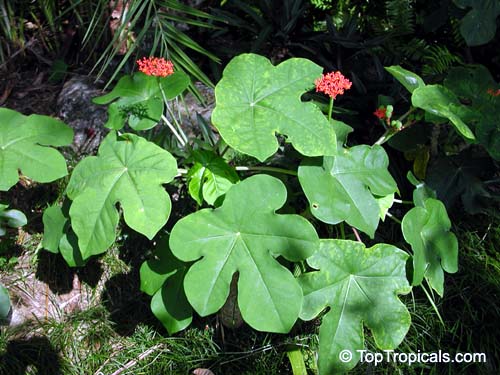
[187,150,239,205]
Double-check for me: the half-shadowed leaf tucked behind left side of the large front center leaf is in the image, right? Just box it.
[140,237,193,334]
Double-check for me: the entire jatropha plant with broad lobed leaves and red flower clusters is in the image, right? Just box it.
[0,54,474,374]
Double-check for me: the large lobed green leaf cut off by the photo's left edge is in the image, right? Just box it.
[0,108,73,191]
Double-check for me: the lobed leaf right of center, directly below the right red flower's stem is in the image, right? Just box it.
[298,145,398,237]
